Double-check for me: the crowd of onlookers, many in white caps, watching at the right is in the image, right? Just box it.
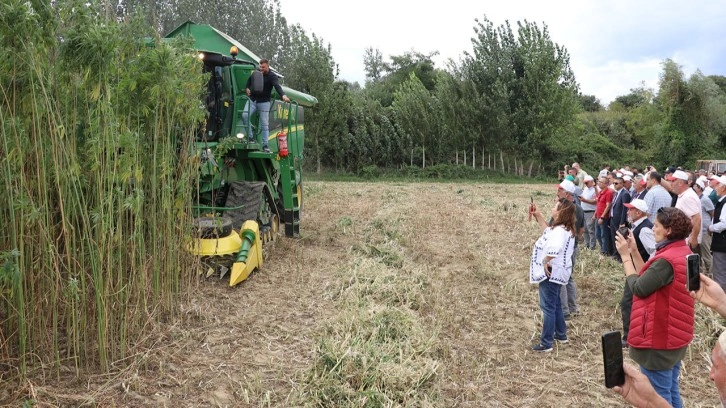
[529,163,726,407]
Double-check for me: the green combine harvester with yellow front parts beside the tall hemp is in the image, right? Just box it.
[171,21,318,286]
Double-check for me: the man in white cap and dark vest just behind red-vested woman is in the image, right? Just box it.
[620,199,655,347]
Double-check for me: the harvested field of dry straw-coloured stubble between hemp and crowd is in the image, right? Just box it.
[7,182,721,407]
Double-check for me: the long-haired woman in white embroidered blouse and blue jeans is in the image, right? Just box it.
[529,200,575,353]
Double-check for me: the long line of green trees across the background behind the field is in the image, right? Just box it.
[71,0,726,174]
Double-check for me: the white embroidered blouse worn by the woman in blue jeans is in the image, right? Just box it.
[529,225,575,285]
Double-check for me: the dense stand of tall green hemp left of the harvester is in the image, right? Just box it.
[0,0,205,374]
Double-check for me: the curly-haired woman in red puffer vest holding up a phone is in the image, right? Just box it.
[615,207,694,407]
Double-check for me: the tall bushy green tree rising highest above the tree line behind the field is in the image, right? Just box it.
[464,18,580,168]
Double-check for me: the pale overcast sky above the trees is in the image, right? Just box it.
[280,0,726,105]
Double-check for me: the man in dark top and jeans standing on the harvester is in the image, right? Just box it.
[242,58,290,153]
